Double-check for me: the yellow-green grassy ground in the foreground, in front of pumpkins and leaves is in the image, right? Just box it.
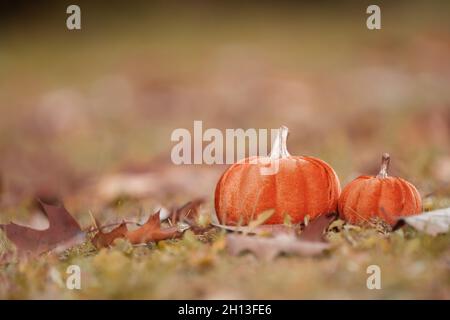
[0,208,450,299]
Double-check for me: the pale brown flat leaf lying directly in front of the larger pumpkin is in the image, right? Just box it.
[226,234,330,261]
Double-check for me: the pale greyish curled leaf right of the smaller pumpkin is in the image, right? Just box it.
[393,208,450,236]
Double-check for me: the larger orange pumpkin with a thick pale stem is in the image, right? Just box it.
[215,127,340,225]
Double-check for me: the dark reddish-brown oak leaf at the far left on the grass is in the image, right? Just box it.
[0,201,85,255]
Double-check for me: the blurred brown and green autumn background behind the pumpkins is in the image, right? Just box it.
[0,1,450,225]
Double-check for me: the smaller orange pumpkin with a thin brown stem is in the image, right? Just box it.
[338,153,422,225]
